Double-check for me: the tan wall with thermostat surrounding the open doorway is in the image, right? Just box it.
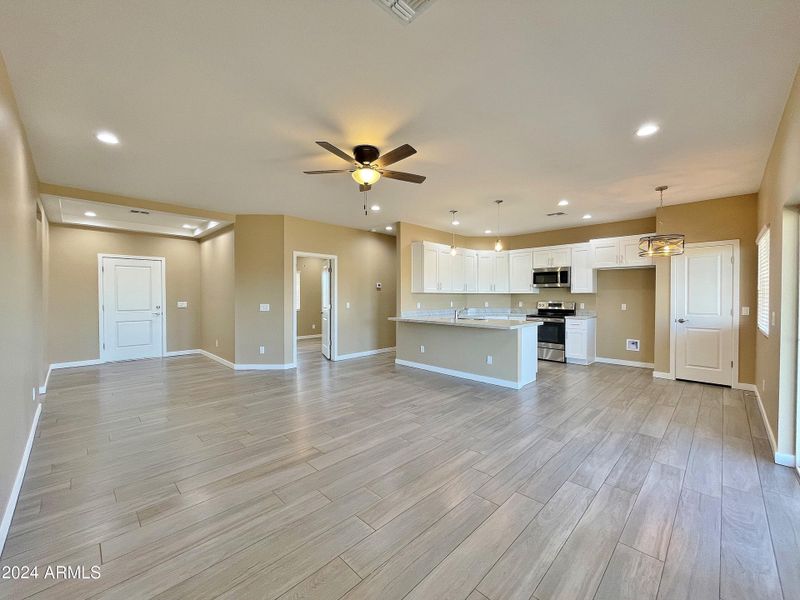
[286,217,397,362]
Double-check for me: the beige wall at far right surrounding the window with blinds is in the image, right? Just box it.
[755,65,800,454]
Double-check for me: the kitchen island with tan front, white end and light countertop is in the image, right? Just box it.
[390,317,541,389]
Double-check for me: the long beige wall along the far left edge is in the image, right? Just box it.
[0,57,47,515]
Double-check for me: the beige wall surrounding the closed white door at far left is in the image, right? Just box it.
[48,225,201,363]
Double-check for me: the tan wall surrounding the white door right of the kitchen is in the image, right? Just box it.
[655,194,757,383]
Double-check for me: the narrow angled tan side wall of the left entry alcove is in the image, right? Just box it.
[200,226,236,362]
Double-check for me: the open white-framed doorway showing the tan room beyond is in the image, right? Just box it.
[292,251,338,365]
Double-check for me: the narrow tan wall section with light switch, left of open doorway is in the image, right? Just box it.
[234,215,291,364]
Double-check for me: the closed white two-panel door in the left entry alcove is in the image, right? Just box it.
[101,257,164,360]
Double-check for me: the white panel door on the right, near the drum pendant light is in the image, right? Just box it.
[672,245,734,385]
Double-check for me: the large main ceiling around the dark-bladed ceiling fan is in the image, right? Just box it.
[0,0,800,234]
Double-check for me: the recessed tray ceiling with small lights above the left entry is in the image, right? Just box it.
[42,194,230,238]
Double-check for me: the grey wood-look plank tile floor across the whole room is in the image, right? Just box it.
[0,341,800,600]
